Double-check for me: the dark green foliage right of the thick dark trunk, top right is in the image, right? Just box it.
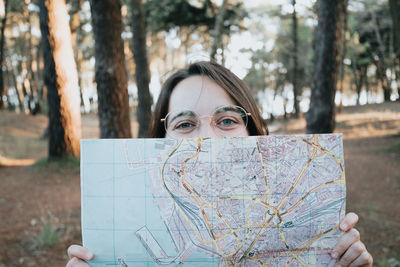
[345,0,396,101]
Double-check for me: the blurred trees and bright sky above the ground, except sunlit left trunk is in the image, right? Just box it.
[0,0,400,157]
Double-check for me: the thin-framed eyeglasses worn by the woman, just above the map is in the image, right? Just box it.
[161,105,251,138]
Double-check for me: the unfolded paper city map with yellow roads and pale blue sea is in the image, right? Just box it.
[81,134,346,266]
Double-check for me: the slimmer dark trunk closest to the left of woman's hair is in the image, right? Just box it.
[131,0,152,137]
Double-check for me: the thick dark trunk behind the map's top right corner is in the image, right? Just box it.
[306,0,346,133]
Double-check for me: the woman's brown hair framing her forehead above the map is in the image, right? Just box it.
[148,61,268,138]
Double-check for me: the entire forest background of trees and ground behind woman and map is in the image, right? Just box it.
[0,0,400,266]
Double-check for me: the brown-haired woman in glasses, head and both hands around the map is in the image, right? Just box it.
[67,62,372,267]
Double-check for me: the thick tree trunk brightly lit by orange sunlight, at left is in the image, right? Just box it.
[40,0,81,159]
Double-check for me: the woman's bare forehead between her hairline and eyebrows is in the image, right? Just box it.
[168,76,235,115]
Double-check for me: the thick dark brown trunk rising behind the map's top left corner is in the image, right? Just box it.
[90,0,132,138]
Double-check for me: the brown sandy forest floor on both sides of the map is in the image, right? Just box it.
[0,103,400,267]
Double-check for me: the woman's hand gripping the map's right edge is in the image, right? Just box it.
[331,212,372,267]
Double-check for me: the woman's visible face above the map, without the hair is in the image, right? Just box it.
[166,75,249,138]
